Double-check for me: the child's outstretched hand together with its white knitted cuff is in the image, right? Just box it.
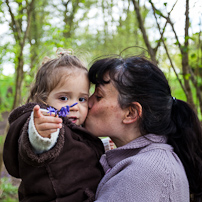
[28,105,62,154]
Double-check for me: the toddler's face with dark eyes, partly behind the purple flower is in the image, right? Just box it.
[47,69,89,125]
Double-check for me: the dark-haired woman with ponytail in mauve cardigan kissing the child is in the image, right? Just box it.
[85,56,202,202]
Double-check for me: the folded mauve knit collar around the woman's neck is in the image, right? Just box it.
[100,134,169,172]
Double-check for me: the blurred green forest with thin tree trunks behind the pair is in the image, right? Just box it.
[0,0,202,201]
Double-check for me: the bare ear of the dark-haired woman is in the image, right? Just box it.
[123,102,142,124]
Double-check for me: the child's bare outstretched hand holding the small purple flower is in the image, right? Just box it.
[33,105,62,138]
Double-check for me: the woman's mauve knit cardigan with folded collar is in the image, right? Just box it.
[96,134,189,202]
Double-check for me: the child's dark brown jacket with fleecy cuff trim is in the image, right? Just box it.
[3,103,104,202]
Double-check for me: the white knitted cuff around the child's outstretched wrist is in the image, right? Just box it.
[28,112,60,154]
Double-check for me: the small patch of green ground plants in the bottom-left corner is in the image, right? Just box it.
[0,177,18,202]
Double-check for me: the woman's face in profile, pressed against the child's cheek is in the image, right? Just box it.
[85,82,125,137]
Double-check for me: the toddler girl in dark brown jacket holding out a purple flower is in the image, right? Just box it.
[3,49,104,202]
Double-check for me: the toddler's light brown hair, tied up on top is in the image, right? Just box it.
[27,48,88,104]
